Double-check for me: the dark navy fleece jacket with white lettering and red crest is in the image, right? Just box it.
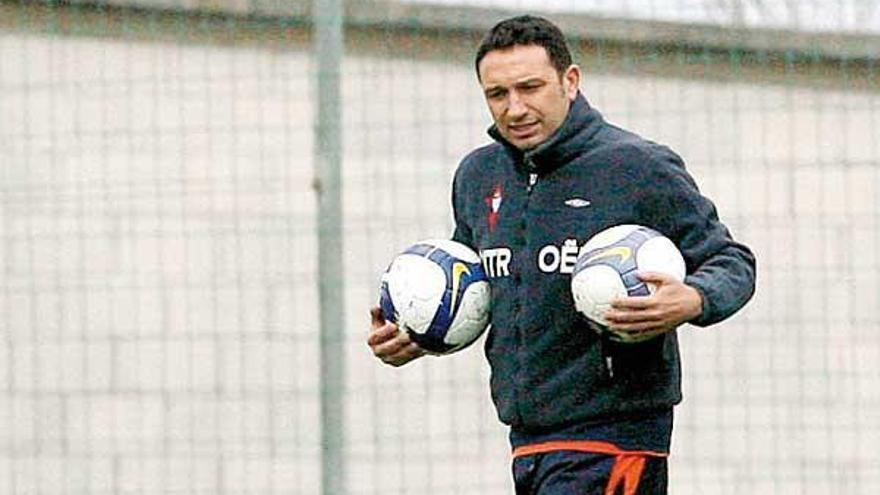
[453,95,755,431]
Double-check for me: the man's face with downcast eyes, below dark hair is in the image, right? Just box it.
[479,45,580,150]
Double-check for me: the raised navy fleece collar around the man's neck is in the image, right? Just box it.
[488,92,603,174]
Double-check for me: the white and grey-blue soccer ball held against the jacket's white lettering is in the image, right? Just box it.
[571,225,685,343]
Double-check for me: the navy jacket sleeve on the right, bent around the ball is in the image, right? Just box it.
[638,148,755,326]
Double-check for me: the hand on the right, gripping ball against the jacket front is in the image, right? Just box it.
[605,272,703,335]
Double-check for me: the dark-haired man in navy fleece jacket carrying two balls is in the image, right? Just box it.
[368,16,755,495]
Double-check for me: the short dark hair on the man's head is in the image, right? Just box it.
[474,15,571,79]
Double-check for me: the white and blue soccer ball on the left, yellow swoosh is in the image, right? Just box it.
[379,239,490,354]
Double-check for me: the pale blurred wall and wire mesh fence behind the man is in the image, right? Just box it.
[0,0,880,495]
